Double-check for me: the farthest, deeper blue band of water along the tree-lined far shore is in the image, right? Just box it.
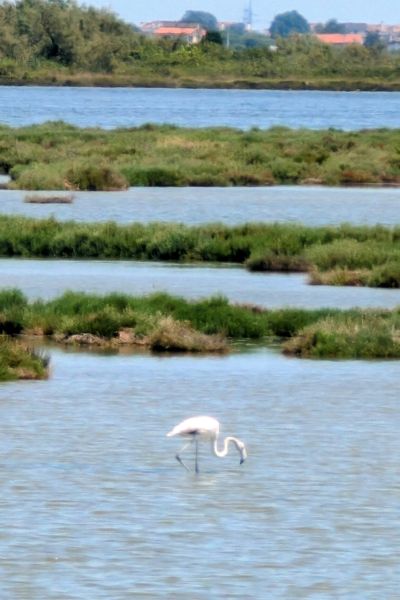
[0,86,400,130]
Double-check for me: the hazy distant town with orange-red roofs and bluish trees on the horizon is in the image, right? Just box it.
[140,9,400,51]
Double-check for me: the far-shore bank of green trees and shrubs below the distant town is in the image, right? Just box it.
[0,0,400,90]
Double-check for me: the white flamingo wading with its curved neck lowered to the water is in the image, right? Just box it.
[167,416,247,473]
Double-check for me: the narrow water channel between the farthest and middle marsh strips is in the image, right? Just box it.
[0,186,400,226]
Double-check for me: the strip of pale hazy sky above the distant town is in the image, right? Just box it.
[87,0,400,29]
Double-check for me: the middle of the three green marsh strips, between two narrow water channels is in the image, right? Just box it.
[0,216,400,288]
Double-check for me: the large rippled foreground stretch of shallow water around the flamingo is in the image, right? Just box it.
[0,350,400,600]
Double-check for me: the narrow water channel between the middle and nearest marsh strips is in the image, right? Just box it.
[0,259,400,309]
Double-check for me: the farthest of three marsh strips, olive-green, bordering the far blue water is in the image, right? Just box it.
[0,122,400,190]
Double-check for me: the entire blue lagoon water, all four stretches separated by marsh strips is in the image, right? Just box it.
[0,82,400,600]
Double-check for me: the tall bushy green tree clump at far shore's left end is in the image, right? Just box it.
[0,0,144,70]
